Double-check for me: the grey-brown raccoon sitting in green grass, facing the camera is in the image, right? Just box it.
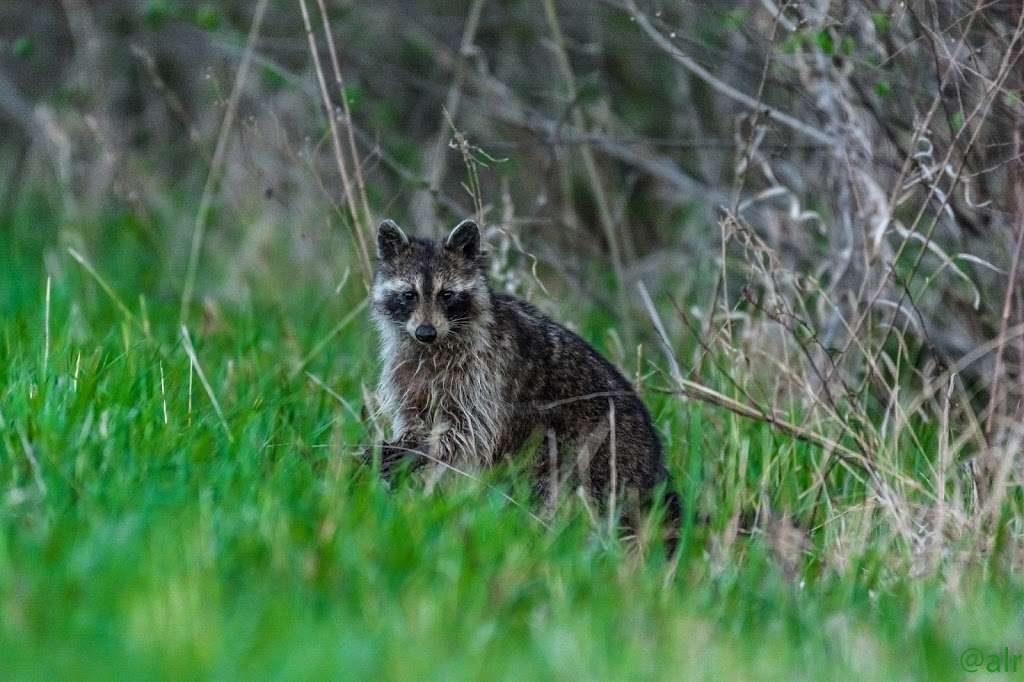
[372,220,681,548]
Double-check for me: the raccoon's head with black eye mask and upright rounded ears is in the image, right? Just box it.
[373,220,490,347]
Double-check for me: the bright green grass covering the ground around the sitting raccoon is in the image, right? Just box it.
[0,201,1024,680]
